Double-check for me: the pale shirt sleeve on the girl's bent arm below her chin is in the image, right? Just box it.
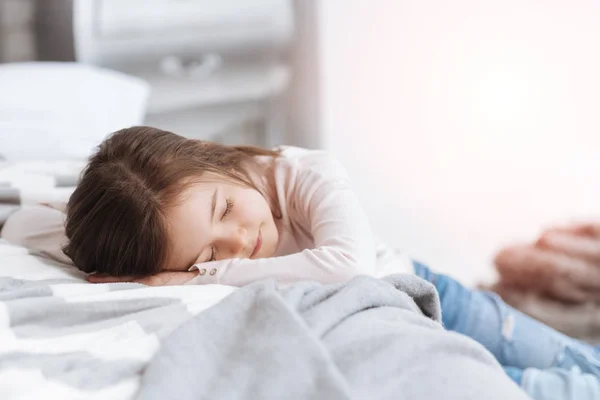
[186,154,376,286]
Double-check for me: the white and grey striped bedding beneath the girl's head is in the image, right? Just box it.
[0,161,234,399]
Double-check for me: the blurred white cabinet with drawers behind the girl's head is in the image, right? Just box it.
[38,0,294,146]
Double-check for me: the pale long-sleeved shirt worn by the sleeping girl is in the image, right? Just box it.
[187,147,413,286]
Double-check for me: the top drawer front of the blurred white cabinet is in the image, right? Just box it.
[75,0,294,65]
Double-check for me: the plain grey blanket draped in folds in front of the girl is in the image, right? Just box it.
[138,275,528,400]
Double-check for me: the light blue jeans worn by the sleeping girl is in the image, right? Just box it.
[414,262,600,400]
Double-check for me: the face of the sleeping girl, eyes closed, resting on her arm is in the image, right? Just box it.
[164,174,279,271]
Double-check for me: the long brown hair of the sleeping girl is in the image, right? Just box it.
[63,126,279,276]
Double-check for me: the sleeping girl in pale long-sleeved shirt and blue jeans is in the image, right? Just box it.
[2,127,600,400]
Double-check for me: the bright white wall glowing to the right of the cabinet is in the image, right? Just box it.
[319,0,600,283]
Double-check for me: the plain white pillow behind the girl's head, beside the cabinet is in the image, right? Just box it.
[0,62,150,161]
